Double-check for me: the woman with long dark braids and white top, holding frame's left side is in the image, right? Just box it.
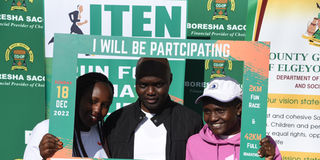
[24,72,114,160]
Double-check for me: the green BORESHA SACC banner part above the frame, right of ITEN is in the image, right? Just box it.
[187,0,248,40]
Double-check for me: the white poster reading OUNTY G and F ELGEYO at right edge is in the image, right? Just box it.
[259,0,320,160]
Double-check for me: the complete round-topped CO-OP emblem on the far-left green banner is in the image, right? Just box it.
[5,43,33,71]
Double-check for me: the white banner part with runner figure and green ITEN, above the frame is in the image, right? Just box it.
[45,0,187,57]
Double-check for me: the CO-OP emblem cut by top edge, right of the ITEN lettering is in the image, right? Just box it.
[207,0,236,20]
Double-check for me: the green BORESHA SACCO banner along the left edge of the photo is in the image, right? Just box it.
[0,0,45,159]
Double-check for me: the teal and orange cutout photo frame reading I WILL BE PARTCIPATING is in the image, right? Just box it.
[49,34,270,159]
